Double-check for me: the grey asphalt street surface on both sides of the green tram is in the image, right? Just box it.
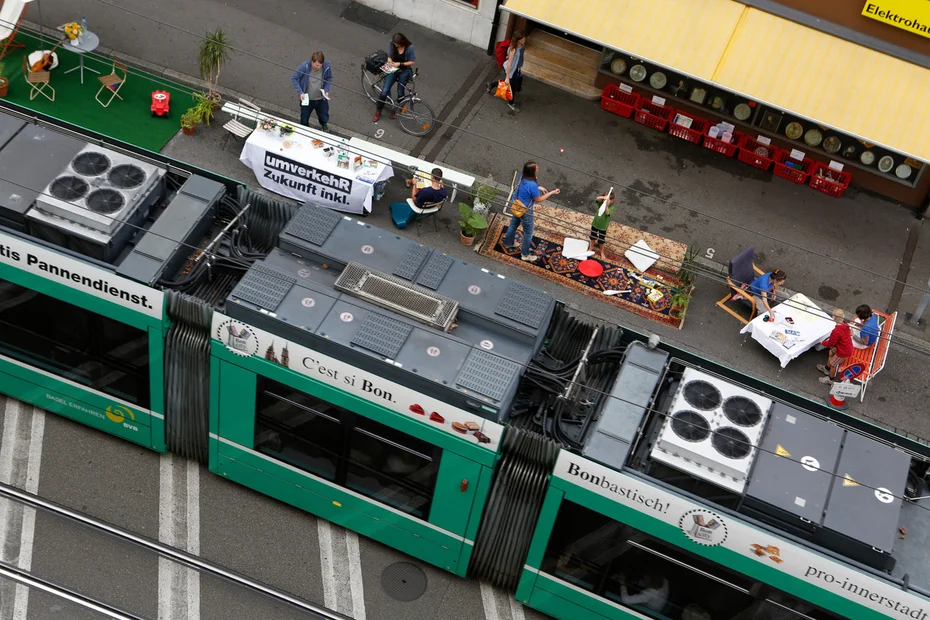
[10,0,930,620]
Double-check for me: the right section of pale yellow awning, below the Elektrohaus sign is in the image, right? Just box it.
[713,8,930,161]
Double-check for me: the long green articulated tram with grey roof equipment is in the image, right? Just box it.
[0,101,930,620]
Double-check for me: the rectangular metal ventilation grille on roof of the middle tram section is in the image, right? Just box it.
[335,262,459,331]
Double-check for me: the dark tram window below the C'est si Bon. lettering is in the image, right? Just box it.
[255,377,442,519]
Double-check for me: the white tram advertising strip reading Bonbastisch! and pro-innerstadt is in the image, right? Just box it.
[553,450,930,620]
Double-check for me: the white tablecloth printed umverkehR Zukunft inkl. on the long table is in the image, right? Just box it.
[239,127,394,213]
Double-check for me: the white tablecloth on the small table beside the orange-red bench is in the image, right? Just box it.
[740,293,836,368]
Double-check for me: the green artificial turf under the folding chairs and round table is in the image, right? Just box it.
[0,31,192,152]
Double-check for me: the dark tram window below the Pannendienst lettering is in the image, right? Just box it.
[0,280,150,409]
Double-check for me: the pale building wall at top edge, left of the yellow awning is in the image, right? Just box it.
[358,0,497,49]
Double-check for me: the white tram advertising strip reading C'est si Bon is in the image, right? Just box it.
[212,312,504,452]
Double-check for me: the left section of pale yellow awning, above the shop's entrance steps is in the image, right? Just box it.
[503,0,743,80]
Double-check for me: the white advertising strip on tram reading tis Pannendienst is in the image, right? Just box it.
[0,233,164,319]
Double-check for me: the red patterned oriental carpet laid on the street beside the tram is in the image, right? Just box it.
[480,212,684,329]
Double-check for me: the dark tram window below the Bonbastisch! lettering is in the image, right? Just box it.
[542,500,838,620]
